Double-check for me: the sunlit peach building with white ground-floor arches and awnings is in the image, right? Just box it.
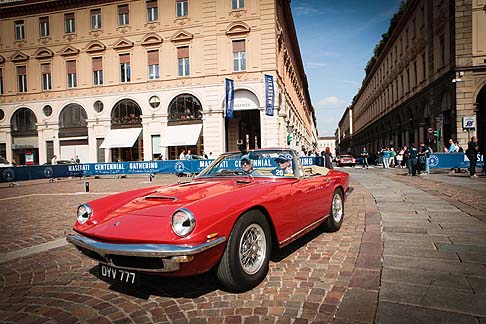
[0,0,317,164]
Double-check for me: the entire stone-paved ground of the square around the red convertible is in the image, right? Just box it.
[0,168,486,324]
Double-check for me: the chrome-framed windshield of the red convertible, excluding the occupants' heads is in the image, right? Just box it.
[196,149,301,179]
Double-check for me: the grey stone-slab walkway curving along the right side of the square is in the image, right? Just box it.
[344,168,486,324]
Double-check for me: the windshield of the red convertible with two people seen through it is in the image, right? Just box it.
[198,150,297,178]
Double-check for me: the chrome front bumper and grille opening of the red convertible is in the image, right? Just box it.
[66,234,226,272]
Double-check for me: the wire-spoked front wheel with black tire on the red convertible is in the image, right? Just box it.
[216,210,272,292]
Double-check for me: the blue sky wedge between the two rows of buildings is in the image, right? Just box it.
[290,0,401,136]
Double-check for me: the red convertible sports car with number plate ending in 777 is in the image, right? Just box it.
[67,149,351,292]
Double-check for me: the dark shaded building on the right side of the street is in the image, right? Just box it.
[352,0,486,153]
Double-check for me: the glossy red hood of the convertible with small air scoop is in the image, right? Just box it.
[75,178,280,242]
